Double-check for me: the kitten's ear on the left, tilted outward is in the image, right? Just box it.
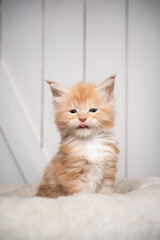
[46,80,67,100]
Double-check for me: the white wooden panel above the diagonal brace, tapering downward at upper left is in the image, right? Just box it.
[2,0,41,141]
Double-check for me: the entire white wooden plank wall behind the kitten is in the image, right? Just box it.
[0,0,160,183]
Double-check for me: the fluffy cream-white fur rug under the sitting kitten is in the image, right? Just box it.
[0,177,160,240]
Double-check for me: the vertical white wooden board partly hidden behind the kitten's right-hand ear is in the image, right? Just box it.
[86,0,125,177]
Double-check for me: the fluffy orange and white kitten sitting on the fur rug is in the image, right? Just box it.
[37,76,119,198]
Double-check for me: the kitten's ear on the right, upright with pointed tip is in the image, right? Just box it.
[97,74,116,101]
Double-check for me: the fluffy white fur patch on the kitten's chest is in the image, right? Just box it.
[63,134,116,192]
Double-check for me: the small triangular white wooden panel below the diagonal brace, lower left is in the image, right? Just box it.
[0,129,25,184]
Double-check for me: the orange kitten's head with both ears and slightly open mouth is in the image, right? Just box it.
[48,76,115,138]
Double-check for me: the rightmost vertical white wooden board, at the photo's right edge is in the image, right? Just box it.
[128,0,160,177]
